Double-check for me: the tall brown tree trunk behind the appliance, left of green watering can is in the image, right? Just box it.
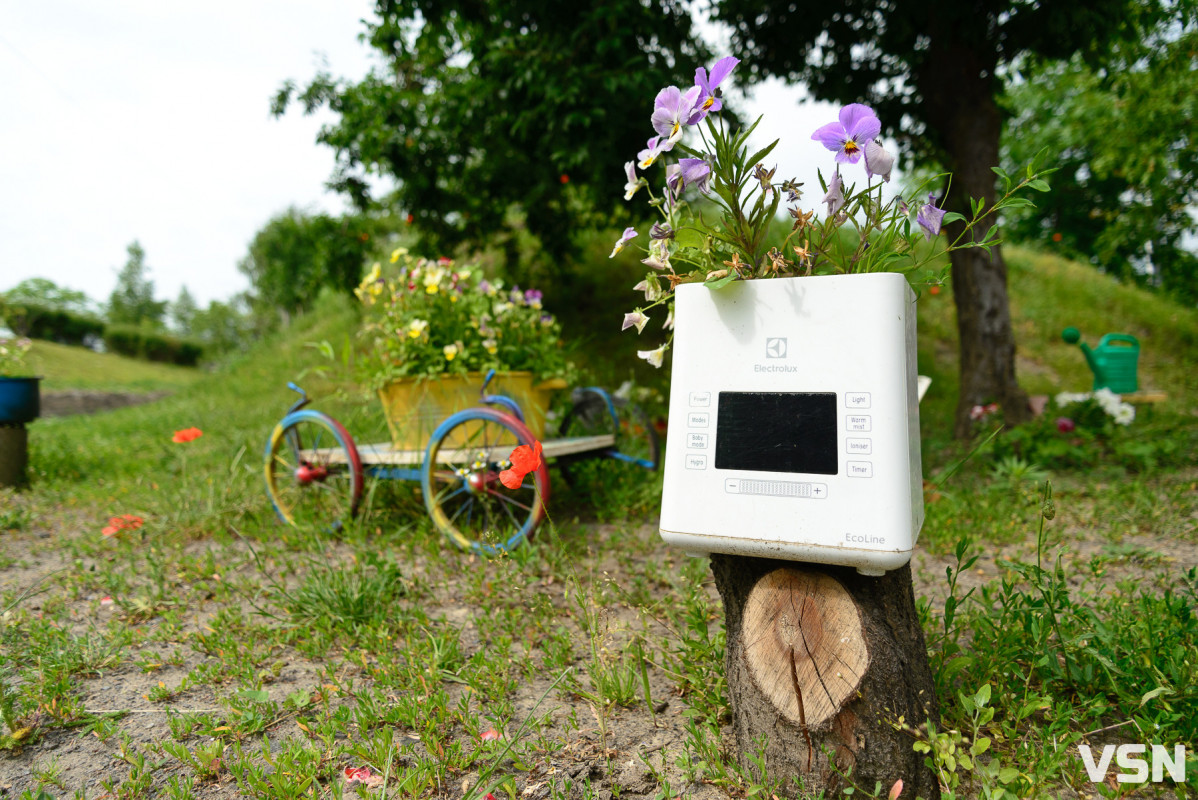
[916,38,1031,438]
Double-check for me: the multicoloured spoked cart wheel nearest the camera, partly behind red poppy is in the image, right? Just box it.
[420,407,549,553]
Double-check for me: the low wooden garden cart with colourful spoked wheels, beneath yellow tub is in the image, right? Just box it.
[266,370,660,553]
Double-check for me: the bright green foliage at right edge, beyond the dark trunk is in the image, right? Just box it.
[1004,26,1198,304]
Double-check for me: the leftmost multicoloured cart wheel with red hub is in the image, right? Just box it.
[266,408,363,528]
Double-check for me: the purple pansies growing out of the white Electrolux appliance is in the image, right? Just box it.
[611,56,1051,366]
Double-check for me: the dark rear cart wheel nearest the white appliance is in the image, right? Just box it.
[557,389,661,489]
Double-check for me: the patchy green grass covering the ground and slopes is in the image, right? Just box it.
[0,259,1198,800]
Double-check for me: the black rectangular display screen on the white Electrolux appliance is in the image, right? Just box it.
[715,392,840,475]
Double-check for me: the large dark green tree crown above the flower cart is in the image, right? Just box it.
[274,0,706,268]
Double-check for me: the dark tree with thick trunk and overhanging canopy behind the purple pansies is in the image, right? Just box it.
[713,0,1193,436]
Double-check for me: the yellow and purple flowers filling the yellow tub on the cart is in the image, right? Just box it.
[355,248,568,388]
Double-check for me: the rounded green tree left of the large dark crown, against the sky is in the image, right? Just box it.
[237,208,379,320]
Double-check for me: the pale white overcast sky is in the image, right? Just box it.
[0,0,852,304]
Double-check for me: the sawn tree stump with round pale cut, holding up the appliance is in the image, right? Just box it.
[712,553,940,800]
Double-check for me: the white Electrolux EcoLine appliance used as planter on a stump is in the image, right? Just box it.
[661,273,924,575]
